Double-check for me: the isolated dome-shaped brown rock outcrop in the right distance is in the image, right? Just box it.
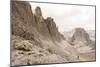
[71,28,91,44]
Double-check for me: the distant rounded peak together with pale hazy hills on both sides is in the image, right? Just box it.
[63,28,95,48]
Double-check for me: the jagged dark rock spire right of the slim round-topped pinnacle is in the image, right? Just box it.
[45,17,65,41]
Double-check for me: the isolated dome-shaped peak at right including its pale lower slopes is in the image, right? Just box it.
[70,28,95,49]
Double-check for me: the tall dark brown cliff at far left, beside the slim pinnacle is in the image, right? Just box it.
[11,1,35,39]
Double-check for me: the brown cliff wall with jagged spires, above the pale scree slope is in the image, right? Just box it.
[11,1,64,40]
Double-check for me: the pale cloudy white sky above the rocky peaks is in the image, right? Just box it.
[30,2,95,32]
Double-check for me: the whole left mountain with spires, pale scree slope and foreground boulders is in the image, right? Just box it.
[11,0,79,66]
